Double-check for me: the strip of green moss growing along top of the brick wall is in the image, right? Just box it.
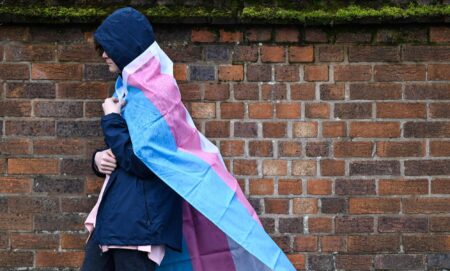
[0,4,450,24]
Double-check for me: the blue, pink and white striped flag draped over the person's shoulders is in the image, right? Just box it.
[114,42,295,271]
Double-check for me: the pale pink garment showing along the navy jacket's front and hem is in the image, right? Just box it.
[84,176,165,265]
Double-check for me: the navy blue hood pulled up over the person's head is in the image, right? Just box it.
[94,7,155,71]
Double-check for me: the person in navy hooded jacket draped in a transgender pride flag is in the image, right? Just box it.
[86,8,295,271]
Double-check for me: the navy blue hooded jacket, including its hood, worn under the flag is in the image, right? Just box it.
[94,8,182,253]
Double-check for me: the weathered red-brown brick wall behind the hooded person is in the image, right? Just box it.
[0,25,450,270]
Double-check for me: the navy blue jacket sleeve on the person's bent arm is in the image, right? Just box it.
[101,113,155,178]
